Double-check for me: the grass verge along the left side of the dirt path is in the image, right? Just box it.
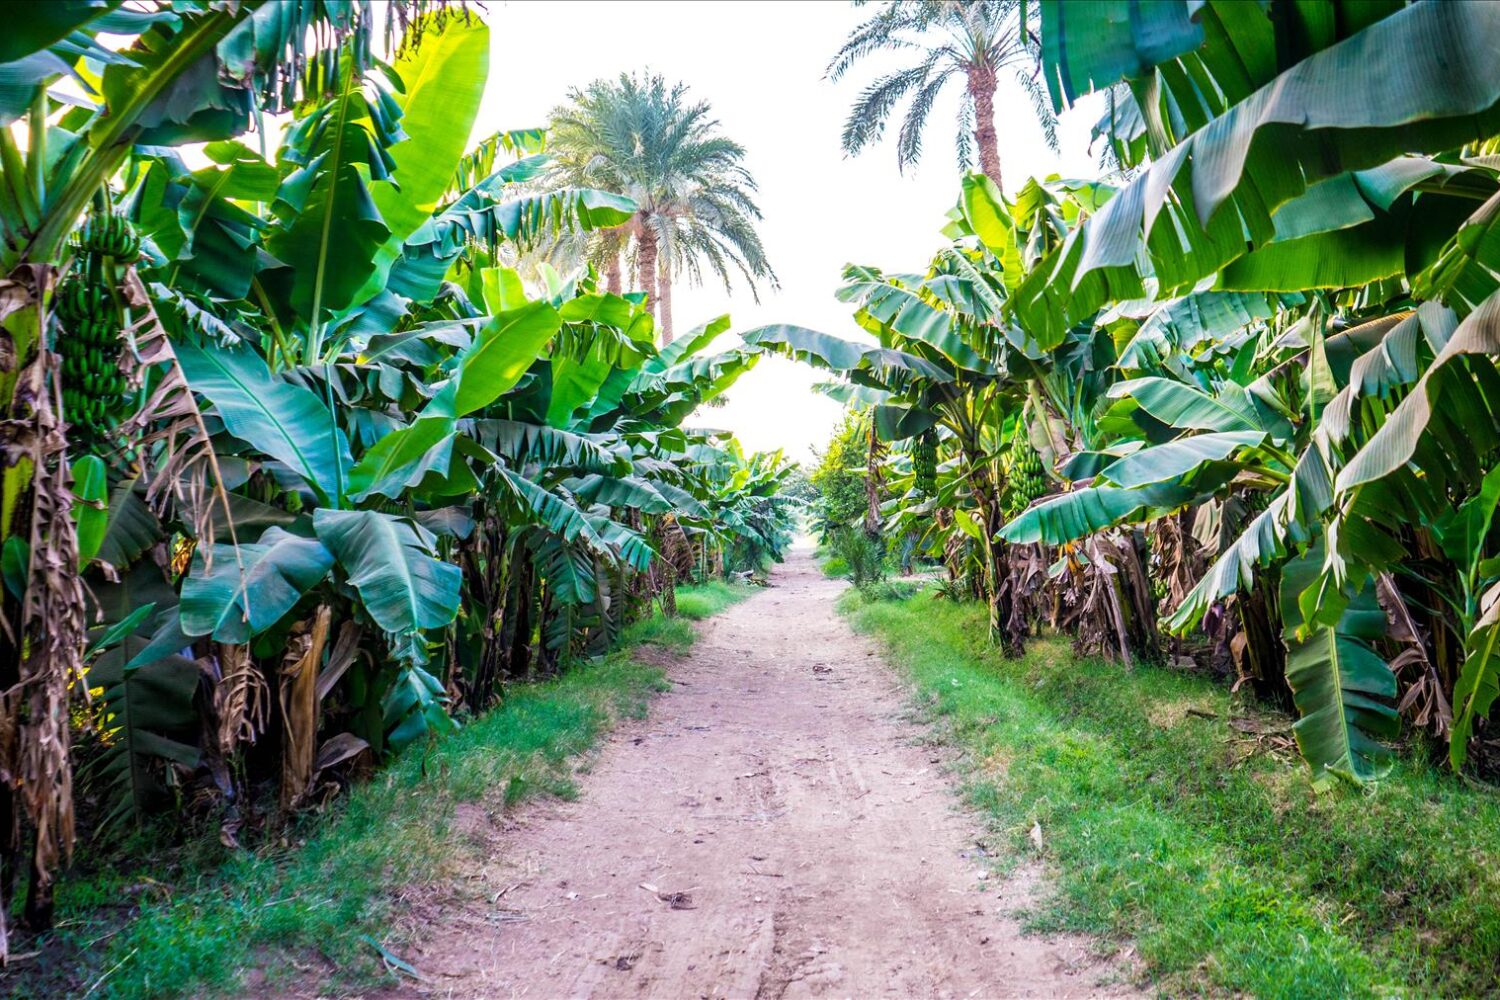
[14,583,753,999]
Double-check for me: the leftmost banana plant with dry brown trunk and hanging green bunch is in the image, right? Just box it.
[0,0,468,952]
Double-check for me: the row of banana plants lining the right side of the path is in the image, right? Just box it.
[750,0,1500,789]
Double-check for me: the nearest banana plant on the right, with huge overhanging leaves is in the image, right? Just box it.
[984,3,1500,784]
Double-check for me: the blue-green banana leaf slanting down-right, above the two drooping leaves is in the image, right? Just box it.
[173,340,354,505]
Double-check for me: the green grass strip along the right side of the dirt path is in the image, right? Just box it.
[843,592,1500,997]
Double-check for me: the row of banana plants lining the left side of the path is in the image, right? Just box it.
[0,0,791,961]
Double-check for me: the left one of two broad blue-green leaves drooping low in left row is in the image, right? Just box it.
[179,526,333,643]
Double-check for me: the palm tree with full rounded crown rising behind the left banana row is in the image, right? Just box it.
[548,73,777,343]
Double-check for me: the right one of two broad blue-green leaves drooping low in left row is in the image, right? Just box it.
[312,508,464,666]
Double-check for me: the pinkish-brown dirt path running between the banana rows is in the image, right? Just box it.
[378,552,1128,999]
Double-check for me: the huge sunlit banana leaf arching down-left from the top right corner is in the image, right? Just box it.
[1014,3,1500,346]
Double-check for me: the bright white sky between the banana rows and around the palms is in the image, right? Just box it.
[477,0,1100,462]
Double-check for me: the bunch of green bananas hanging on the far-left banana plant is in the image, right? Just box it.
[56,214,141,441]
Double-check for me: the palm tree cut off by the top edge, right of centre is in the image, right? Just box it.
[828,0,1058,184]
